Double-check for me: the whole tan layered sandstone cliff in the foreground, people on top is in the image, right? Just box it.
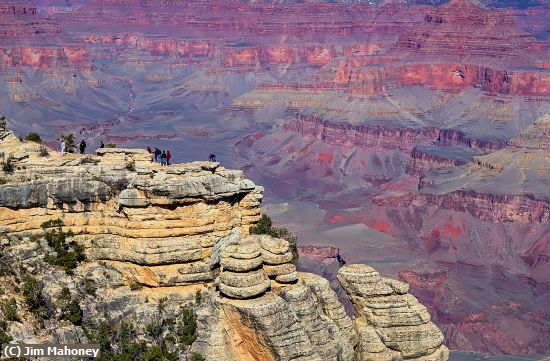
[0,134,448,361]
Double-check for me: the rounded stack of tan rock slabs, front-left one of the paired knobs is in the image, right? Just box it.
[216,238,271,299]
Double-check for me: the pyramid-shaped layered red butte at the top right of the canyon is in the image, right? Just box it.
[396,0,547,66]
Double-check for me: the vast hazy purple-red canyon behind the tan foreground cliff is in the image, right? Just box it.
[0,0,550,355]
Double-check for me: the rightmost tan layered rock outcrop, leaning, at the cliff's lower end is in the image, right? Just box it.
[338,264,449,361]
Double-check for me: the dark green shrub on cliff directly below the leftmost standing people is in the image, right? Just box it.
[42,219,86,275]
